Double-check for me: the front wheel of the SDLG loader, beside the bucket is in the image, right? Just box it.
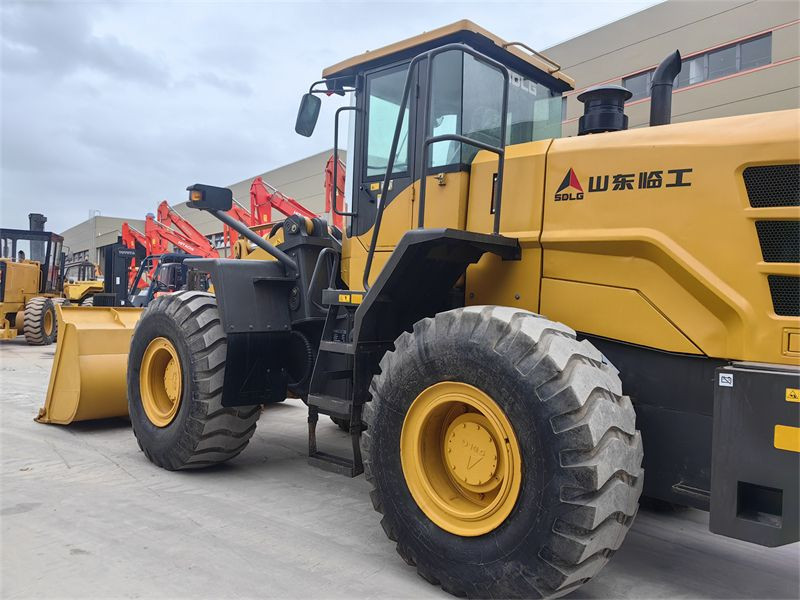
[128,291,261,470]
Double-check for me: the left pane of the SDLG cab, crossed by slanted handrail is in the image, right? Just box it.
[365,65,409,179]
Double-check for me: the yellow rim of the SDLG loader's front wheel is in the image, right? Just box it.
[139,337,183,427]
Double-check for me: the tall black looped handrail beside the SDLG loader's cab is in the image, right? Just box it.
[362,43,509,291]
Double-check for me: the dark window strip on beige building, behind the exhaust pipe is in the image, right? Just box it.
[622,33,772,102]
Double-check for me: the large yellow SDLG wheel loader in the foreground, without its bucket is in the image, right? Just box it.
[50,21,800,598]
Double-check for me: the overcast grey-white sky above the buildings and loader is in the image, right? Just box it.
[0,0,655,231]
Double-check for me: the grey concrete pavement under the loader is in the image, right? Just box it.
[0,338,800,598]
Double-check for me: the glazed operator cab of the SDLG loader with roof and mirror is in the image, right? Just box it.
[295,20,573,245]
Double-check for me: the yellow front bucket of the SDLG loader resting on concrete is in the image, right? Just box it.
[36,306,144,425]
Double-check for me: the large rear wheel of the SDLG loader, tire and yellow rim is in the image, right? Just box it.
[362,306,643,598]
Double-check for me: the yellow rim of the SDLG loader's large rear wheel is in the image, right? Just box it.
[400,381,522,536]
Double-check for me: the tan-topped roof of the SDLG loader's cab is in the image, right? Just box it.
[322,19,575,92]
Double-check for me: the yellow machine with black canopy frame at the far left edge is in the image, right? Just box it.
[0,229,65,346]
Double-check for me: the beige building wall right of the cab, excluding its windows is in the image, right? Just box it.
[545,0,800,135]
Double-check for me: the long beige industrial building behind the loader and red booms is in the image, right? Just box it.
[63,0,800,261]
